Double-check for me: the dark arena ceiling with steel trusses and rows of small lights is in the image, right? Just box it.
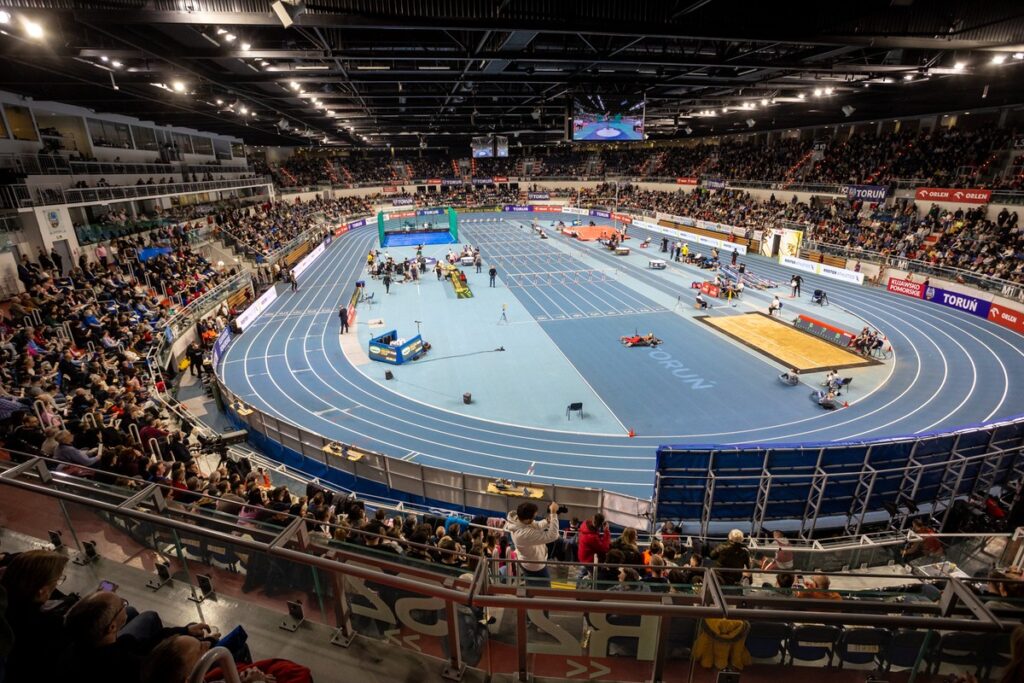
[0,0,1024,146]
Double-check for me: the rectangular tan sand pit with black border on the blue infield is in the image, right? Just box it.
[697,312,879,373]
